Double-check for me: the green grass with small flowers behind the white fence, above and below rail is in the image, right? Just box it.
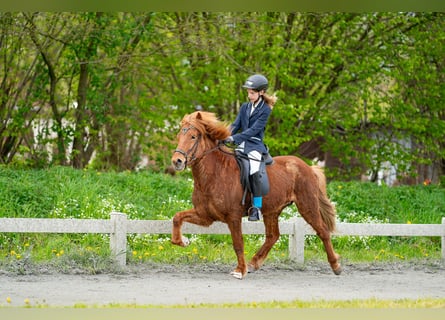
[0,166,445,273]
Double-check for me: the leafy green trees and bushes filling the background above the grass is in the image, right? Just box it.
[0,12,445,182]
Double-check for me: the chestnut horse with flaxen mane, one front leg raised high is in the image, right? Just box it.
[171,111,341,279]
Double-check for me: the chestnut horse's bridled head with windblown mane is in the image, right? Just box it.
[172,111,230,171]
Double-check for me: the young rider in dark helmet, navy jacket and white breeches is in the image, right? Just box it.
[225,74,277,221]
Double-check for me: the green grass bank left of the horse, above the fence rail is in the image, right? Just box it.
[0,167,192,219]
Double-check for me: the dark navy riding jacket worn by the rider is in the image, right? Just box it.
[231,100,272,153]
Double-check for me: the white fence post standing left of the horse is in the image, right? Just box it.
[110,212,127,266]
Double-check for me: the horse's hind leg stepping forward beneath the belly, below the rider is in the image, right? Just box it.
[248,214,280,272]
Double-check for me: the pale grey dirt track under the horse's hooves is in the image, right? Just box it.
[0,262,445,306]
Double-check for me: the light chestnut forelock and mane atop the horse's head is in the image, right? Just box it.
[181,111,230,140]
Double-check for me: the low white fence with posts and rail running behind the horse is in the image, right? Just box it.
[0,212,445,266]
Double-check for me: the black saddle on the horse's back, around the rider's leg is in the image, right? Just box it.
[235,151,274,205]
